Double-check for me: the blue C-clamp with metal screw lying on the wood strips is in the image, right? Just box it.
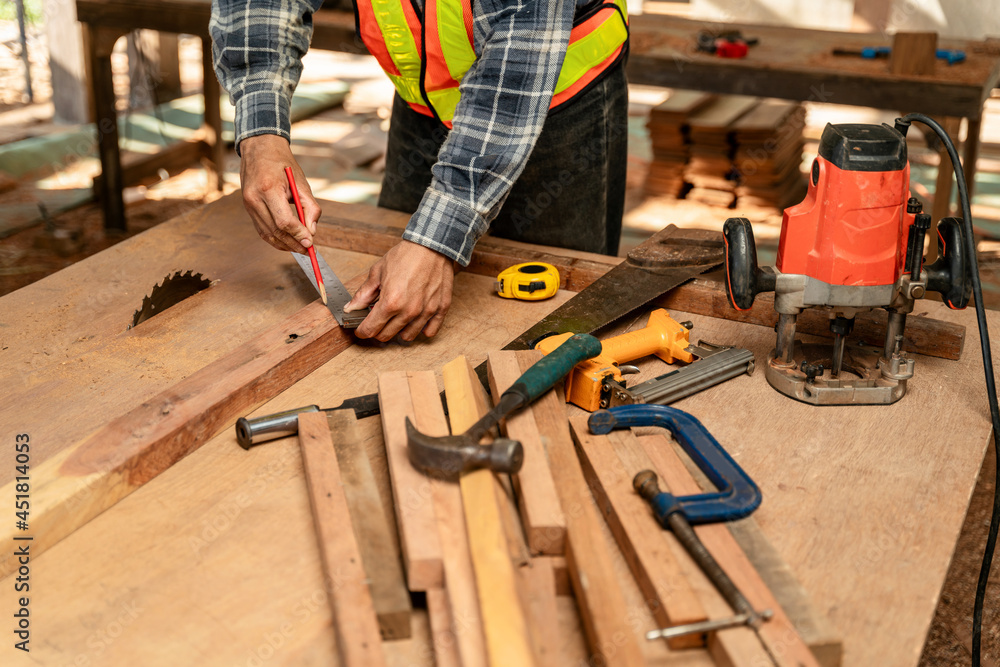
[587,405,772,640]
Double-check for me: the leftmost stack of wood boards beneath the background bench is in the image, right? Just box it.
[646,90,715,197]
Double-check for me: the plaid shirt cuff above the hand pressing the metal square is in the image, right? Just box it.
[403,187,489,267]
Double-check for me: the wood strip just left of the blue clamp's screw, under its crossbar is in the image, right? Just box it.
[570,416,708,649]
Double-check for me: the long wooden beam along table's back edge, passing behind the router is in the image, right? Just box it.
[316,202,965,359]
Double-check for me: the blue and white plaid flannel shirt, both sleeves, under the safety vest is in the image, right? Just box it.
[209,0,593,266]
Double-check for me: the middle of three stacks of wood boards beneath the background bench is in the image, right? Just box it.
[684,95,759,207]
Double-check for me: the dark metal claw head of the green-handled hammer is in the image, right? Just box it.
[406,417,524,479]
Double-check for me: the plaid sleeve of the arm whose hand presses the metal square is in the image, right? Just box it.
[403,0,576,266]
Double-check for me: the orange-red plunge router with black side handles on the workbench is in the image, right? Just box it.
[723,121,971,405]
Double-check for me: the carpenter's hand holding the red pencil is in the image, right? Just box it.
[240,134,321,252]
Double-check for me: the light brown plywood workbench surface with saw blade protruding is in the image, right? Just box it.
[0,195,1000,665]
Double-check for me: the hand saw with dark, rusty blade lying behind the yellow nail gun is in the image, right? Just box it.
[320,225,725,414]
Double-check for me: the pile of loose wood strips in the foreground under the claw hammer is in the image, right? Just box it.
[364,350,840,667]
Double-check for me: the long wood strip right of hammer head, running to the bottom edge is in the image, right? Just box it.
[493,351,645,665]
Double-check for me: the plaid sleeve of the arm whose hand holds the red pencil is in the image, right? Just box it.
[209,0,323,152]
